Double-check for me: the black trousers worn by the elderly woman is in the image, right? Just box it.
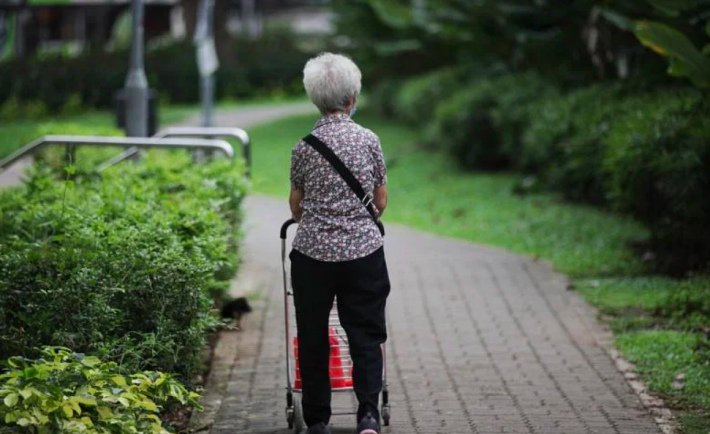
[290,248,390,426]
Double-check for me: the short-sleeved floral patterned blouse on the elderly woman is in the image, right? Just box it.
[291,114,387,262]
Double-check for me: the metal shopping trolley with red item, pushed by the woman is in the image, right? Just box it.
[281,220,390,434]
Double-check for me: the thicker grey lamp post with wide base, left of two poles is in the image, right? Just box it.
[126,0,148,137]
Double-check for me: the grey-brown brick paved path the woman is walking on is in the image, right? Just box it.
[211,197,660,434]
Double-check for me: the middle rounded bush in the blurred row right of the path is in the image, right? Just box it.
[428,73,556,169]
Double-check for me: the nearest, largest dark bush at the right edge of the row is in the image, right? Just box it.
[519,83,710,271]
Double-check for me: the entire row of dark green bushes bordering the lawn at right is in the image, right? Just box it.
[386,65,710,272]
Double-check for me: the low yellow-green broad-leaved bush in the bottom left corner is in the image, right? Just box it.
[0,347,200,434]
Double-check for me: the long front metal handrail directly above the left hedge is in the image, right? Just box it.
[0,136,234,170]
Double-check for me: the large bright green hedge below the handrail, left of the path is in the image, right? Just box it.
[0,149,246,378]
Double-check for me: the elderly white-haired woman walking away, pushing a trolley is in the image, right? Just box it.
[290,53,390,434]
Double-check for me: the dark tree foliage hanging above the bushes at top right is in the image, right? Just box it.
[335,0,710,85]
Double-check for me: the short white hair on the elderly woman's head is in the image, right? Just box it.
[303,53,362,114]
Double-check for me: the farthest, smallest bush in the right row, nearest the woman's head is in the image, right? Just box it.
[394,68,467,125]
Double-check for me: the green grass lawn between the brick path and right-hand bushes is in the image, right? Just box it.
[250,110,710,434]
